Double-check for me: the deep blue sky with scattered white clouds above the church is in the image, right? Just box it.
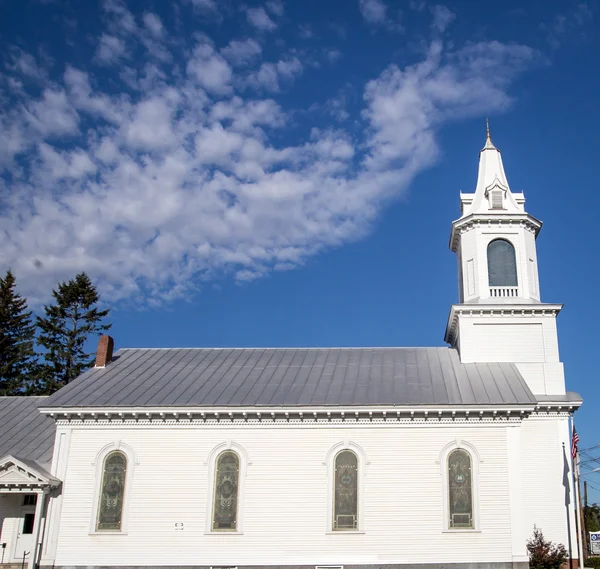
[0,0,600,500]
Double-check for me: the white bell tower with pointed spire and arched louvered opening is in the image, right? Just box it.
[445,121,565,395]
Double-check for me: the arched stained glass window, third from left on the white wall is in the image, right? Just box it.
[333,450,358,530]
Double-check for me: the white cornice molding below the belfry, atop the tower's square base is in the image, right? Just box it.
[444,303,563,346]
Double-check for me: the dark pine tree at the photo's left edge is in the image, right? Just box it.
[0,270,37,395]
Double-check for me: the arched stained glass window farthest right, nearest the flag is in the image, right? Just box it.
[448,449,474,528]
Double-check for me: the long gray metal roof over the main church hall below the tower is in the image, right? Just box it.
[44,348,535,407]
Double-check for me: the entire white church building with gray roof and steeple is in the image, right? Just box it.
[0,132,582,569]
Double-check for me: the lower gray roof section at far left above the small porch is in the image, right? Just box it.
[0,397,56,467]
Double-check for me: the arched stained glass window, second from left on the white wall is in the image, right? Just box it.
[212,450,240,531]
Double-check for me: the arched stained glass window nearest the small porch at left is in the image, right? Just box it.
[96,451,127,531]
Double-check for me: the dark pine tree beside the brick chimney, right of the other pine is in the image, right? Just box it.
[36,273,111,394]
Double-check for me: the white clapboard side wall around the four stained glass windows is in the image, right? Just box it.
[51,424,512,566]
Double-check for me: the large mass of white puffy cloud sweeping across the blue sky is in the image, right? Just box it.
[0,13,537,303]
